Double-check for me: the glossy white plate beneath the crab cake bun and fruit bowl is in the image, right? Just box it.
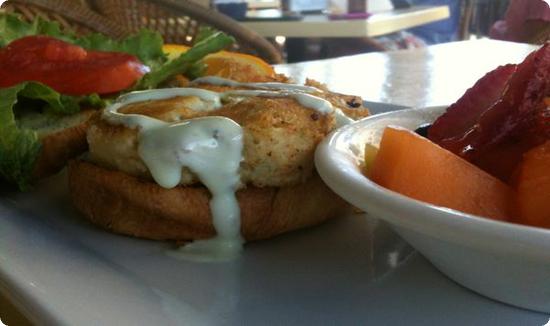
[0,108,548,325]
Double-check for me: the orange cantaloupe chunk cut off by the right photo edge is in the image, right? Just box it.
[516,140,550,228]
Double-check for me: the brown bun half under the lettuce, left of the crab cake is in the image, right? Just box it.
[32,110,97,179]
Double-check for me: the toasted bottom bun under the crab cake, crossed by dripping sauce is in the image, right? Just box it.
[69,160,350,241]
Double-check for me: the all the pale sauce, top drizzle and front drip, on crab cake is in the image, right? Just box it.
[103,77,353,261]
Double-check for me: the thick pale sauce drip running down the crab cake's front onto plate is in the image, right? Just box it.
[142,117,243,260]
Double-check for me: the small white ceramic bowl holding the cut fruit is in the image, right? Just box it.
[315,108,550,313]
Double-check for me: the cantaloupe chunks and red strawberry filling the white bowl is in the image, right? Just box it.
[366,43,550,228]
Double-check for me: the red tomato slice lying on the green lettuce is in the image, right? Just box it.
[0,36,149,95]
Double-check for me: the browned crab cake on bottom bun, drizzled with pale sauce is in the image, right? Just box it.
[69,81,368,244]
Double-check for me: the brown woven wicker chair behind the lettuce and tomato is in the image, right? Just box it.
[2,0,282,63]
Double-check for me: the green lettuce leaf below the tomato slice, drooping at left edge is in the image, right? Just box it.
[0,82,104,190]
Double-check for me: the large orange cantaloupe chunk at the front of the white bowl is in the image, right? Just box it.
[369,126,514,220]
